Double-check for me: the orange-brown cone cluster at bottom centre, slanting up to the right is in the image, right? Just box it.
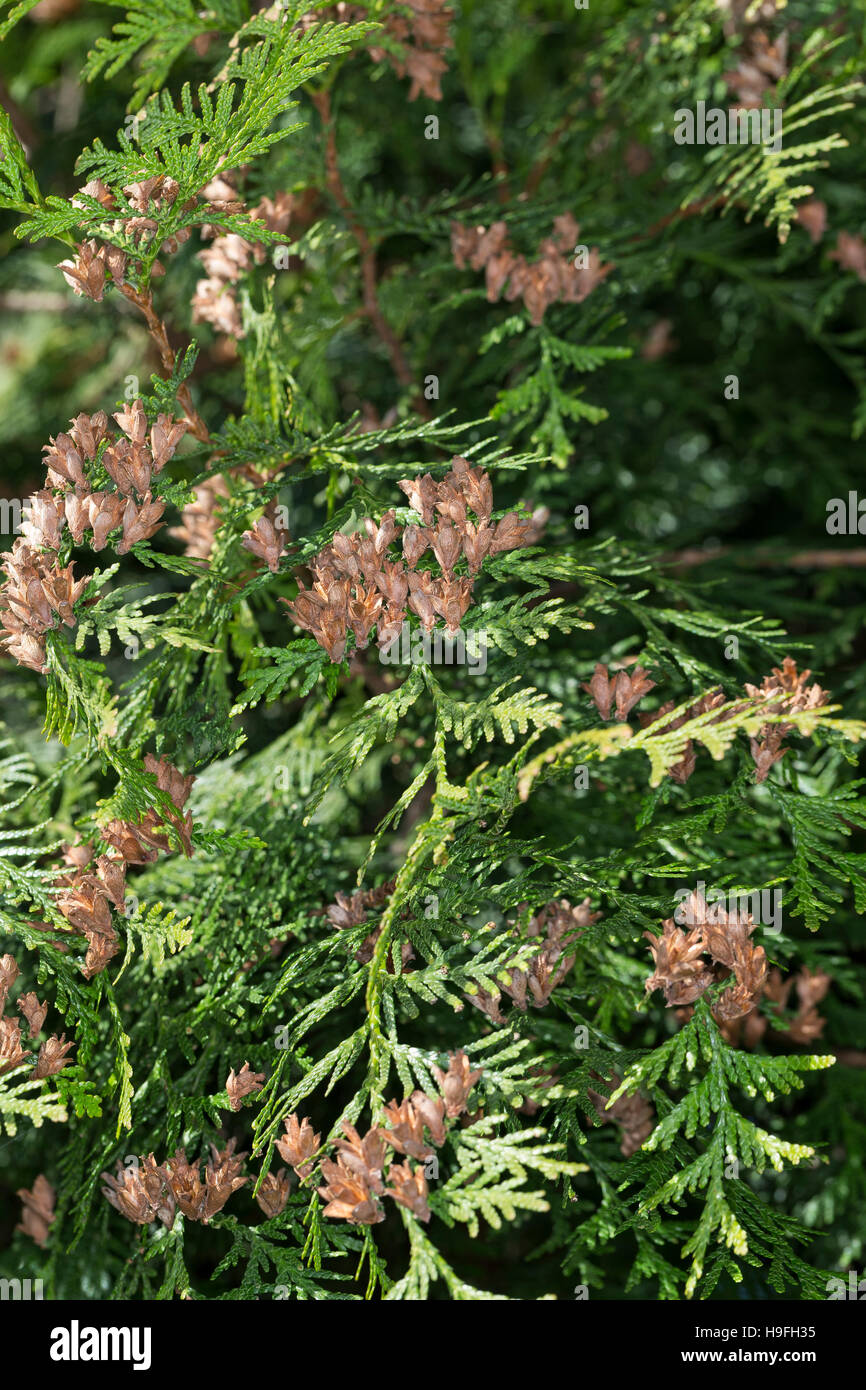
[277,1049,481,1226]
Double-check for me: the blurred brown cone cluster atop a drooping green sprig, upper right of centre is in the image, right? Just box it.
[450,213,613,325]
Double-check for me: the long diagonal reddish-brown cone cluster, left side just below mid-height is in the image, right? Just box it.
[49,753,195,980]
